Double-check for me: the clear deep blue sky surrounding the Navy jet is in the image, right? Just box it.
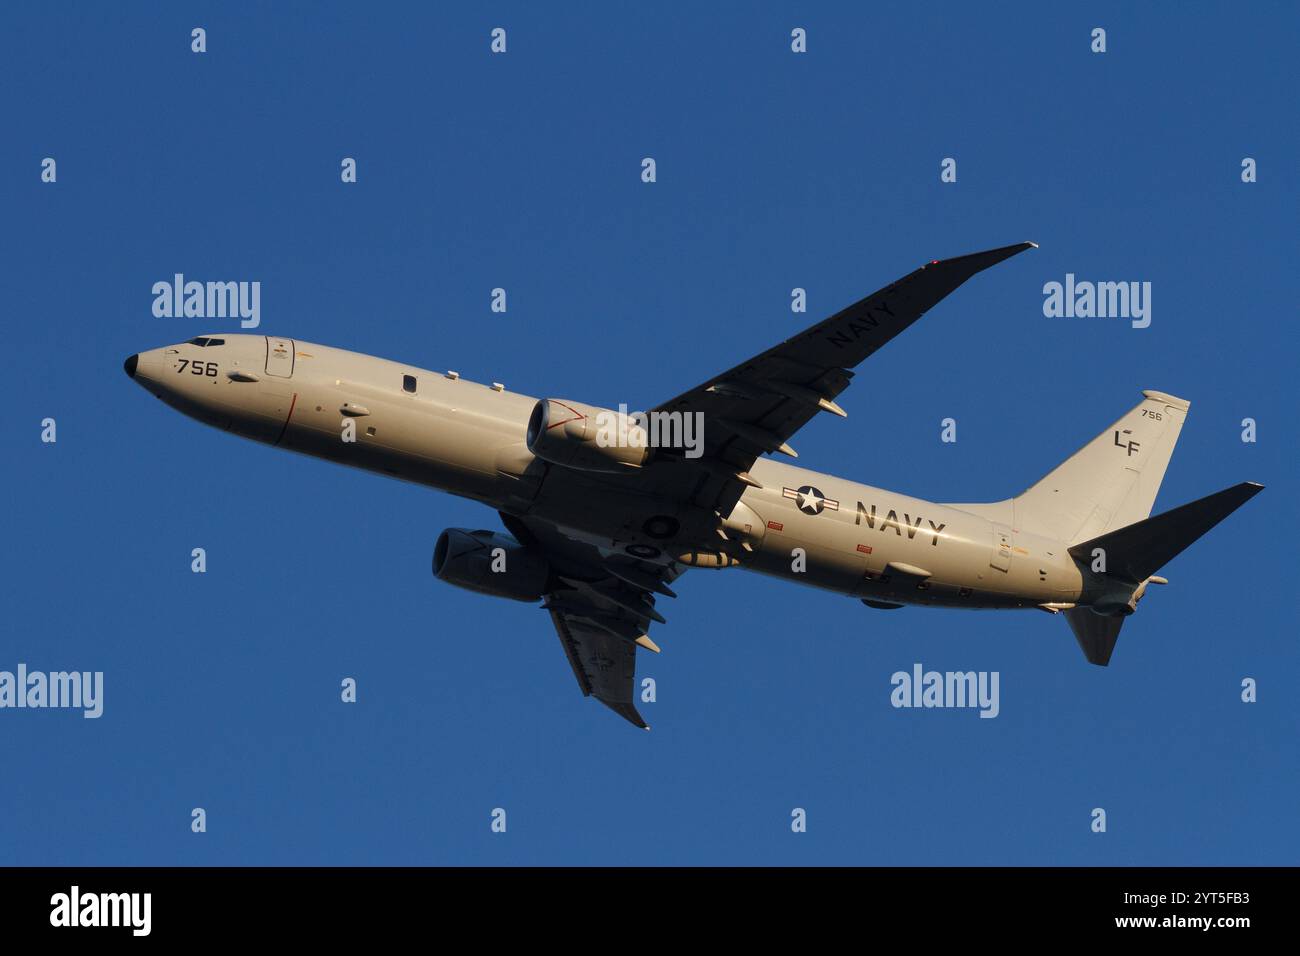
[0,3,1300,864]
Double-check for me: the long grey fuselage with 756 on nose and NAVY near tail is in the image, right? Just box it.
[127,334,1087,609]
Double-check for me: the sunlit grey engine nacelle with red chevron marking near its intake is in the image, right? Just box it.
[527,398,651,472]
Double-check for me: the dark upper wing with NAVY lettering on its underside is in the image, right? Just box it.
[647,242,1036,515]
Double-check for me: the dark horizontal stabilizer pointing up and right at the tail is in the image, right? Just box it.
[1070,481,1264,587]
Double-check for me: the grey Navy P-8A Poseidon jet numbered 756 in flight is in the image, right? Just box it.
[125,242,1261,727]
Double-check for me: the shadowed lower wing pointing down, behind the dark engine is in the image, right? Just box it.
[501,512,684,730]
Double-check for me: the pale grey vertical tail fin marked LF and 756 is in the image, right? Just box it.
[1013,390,1191,544]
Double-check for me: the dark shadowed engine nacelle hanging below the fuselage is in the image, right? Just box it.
[433,528,550,601]
